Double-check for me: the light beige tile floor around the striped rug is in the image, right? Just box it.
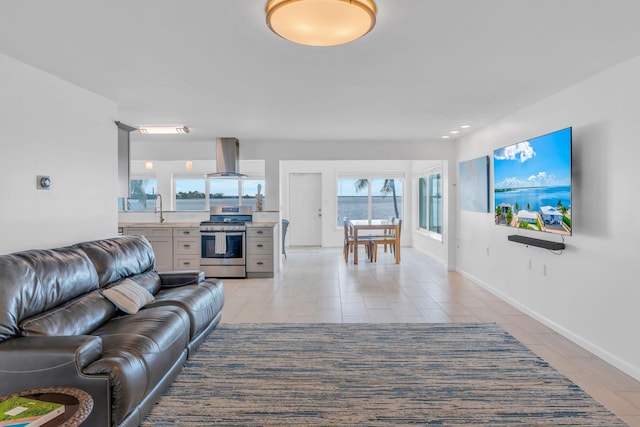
[222,248,640,426]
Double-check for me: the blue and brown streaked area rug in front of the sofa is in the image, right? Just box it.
[142,324,625,426]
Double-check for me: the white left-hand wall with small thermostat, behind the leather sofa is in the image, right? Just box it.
[0,54,118,253]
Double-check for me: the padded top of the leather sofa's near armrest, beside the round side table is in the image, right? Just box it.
[0,335,102,375]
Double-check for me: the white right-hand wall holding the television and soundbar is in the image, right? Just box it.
[456,57,640,379]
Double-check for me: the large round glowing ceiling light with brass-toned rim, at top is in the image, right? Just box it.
[265,0,376,46]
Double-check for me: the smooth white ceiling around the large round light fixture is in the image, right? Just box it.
[0,0,640,145]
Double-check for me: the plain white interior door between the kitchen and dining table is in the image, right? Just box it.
[287,173,322,246]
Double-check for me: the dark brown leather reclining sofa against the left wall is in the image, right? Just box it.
[0,236,224,426]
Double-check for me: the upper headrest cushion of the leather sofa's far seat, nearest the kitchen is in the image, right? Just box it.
[74,236,156,287]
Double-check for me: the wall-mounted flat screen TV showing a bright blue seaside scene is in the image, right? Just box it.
[493,127,572,235]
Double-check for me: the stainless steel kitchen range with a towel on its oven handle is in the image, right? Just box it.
[200,206,253,277]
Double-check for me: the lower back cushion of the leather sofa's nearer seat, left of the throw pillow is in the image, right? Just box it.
[20,291,116,336]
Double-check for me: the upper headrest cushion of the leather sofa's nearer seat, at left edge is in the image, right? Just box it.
[0,247,98,341]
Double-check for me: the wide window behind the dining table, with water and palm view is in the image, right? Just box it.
[337,177,404,226]
